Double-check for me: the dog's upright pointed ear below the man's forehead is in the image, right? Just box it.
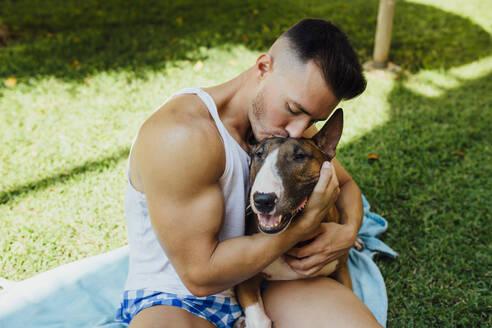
[313,108,343,160]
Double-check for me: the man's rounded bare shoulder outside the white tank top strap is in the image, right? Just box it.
[133,95,225,192]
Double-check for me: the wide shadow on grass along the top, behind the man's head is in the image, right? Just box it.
[0,0,492,83]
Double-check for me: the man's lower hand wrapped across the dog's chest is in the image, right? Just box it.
[284,222,357,276]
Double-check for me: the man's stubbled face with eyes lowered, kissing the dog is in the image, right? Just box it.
[249,61,339,141]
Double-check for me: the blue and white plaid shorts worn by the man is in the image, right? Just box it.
[116,289,242,328]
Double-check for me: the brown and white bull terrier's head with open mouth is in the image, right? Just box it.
[250,108,343,234]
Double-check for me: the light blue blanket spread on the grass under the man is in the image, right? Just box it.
[0,198,396,328]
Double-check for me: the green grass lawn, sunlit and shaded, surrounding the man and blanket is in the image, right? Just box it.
[0,0,492,327]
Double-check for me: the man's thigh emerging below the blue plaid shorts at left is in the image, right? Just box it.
[130,305,215,328]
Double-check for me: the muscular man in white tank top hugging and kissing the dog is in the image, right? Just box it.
[116,19,378,328]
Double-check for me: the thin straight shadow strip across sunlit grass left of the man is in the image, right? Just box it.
[0,147,130,205]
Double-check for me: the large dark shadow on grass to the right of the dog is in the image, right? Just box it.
[338,73,492,327]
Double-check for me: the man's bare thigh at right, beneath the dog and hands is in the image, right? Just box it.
[263,277,381,328]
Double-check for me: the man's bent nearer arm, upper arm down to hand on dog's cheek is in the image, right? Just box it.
[134,111,338,296]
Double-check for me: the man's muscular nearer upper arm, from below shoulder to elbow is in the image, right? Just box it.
[135,120,225,280]
